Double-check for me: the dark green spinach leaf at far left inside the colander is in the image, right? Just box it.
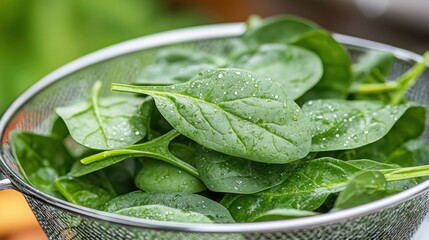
[9,131,73,198]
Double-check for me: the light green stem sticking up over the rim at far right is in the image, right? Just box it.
[390,52,429,105]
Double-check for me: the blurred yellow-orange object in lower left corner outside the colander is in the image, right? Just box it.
[0,190,47,240]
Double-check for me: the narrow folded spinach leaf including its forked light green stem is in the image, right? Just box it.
[70,130,198,177]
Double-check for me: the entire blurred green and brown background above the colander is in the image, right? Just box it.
[0,0,429,115]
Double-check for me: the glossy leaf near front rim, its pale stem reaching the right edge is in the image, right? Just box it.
[221,158,412,222]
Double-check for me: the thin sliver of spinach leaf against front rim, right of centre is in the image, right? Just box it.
[249,208,320,222]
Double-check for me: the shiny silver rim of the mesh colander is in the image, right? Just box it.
[0,23,429,233]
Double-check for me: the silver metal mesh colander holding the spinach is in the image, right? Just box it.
[0,24,429,240]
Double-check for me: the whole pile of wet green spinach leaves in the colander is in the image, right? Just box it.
[10,16,429,223]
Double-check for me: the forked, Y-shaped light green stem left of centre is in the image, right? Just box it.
[80,130,199,178]
